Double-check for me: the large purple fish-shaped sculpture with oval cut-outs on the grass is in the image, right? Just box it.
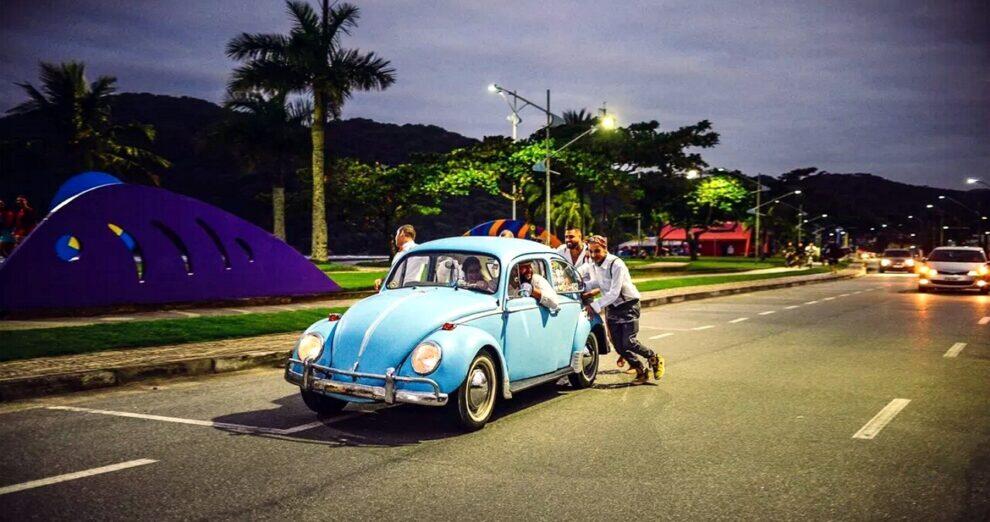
[0,173,340,312]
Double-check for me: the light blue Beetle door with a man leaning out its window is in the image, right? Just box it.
[502,257,559,381]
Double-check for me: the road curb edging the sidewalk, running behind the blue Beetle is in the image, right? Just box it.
[0,271,861,402]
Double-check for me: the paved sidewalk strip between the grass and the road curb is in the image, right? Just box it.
[0,269,863,401]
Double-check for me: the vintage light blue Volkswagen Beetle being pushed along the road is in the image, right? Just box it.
[285,237,608,430]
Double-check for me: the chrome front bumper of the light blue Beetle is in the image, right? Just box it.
[285,357,447,406]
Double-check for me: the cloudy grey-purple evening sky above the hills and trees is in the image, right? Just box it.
[0,0,990,188]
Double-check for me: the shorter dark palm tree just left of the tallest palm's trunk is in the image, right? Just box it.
[220,92,313,241]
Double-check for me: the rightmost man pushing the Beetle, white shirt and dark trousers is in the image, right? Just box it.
[583,236,664,384]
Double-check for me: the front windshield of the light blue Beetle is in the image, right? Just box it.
[385,252,501,294]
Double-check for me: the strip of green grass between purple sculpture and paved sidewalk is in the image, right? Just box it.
[0,308,346,361]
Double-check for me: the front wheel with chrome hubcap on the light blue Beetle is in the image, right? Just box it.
[447,352,498,431]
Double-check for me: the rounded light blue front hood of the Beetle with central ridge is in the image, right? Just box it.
[330,287,498,374]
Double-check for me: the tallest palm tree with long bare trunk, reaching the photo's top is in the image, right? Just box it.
[227,0,395,261]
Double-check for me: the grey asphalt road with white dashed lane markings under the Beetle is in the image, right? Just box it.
[0,275,990,520]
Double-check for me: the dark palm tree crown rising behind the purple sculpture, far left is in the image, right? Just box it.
[7,62,171,184]
